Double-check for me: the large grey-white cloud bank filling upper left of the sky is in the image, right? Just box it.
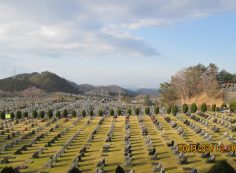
[0,0,236,58]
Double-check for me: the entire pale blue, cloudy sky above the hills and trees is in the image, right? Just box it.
[0,0,236,88]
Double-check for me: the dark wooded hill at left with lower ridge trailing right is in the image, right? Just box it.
[0,71,138,96]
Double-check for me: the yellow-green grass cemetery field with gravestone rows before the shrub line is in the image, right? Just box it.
[0,104,236,173]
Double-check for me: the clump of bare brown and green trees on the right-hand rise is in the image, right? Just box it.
[160,63,236,106]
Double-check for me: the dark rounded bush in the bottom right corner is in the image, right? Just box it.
[207,160,235,173]
